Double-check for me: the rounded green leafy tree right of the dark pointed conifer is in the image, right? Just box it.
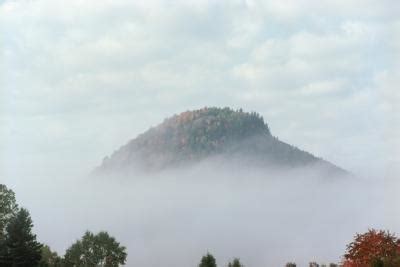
[65,231,127,267]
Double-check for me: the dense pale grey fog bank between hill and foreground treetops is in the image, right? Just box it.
[2,162,400,267]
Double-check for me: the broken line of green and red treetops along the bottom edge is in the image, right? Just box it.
[0,184,400,267]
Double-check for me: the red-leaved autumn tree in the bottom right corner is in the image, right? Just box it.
[344,229,400,267]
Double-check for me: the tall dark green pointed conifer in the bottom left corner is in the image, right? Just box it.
[2,208,42,267]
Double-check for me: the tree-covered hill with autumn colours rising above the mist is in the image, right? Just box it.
[96,107,342,173]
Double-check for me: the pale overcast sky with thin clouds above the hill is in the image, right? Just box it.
[0,0,400,181]
